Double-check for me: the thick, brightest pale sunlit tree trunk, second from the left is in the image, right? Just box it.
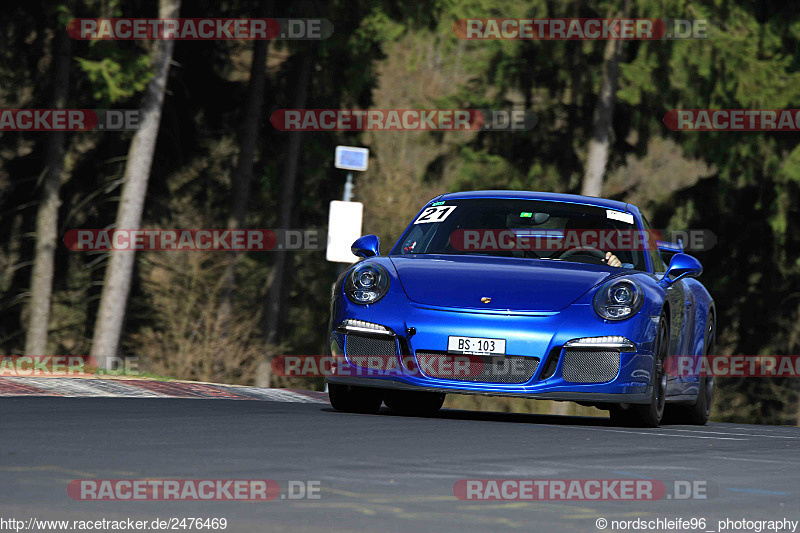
[91,0,180,365]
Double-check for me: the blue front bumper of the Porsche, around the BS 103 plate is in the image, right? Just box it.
[327,300,658,404]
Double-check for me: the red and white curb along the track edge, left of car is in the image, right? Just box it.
[0,376,328,404]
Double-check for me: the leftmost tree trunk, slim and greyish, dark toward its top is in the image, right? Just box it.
[25,20,72,355]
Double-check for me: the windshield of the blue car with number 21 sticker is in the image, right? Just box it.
[391,198,647,270]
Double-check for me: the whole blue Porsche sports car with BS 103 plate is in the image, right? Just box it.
[327,191,716,427]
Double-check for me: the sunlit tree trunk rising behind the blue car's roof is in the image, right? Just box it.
[581,13,628,196]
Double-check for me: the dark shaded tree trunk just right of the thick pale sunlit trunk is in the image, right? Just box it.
[219,2,271,324]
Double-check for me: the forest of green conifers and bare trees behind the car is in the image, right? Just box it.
[0,0,800,425]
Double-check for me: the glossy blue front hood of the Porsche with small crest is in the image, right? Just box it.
[391,254,614,312]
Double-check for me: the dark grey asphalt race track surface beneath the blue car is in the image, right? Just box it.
[0,396,800,532]
